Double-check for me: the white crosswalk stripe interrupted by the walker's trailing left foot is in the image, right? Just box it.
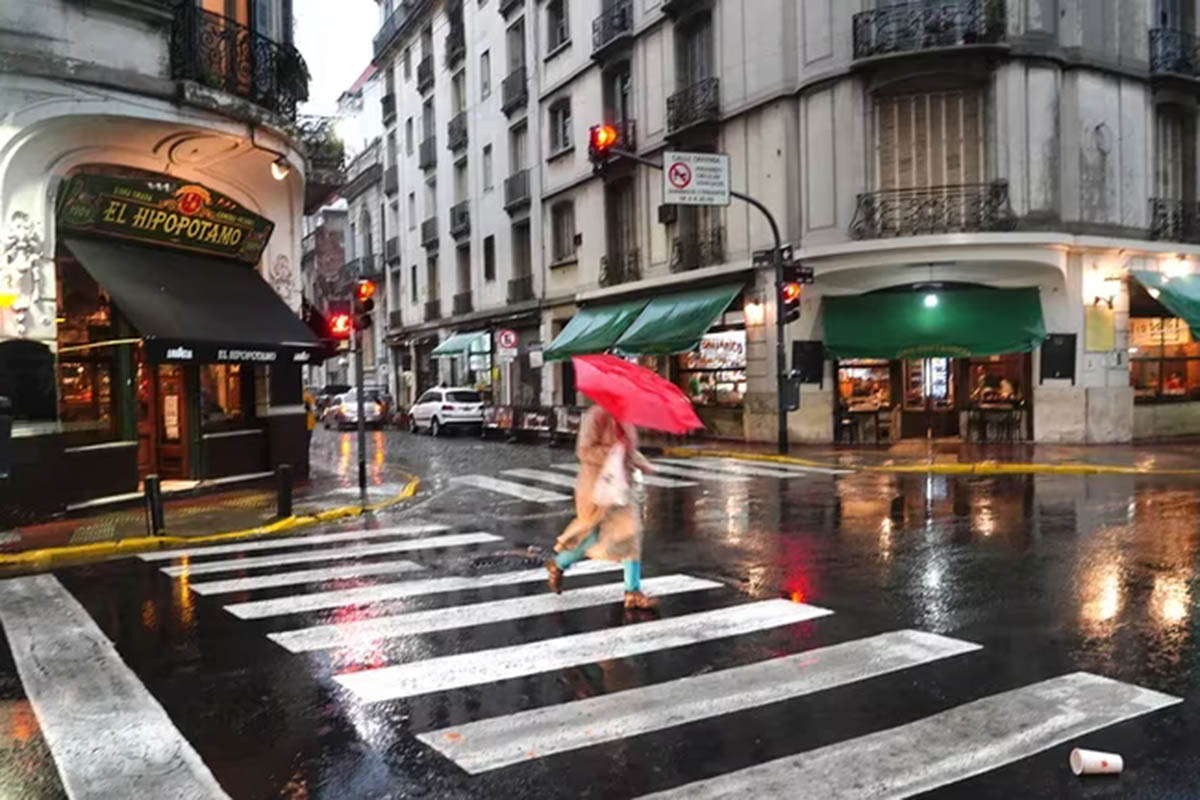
[226,561,622,619]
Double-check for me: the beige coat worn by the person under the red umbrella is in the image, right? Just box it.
[557,405,649,561]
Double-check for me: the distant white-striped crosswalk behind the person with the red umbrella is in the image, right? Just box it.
[451,458,850,504]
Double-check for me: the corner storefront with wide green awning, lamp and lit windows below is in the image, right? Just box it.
[824,285,1045,443]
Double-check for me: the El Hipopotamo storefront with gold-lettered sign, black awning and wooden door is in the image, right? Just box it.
[0,166,324,513]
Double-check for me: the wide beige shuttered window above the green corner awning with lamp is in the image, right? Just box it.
[875,90,986,190]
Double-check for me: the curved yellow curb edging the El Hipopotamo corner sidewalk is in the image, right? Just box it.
[0,475,421,569]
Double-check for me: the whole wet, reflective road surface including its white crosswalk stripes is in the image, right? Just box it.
[0,432,1200,799]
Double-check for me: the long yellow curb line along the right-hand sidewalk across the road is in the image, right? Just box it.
[662,447,1200,476]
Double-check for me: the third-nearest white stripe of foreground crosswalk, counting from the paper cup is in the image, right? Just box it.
[335,600,833,703]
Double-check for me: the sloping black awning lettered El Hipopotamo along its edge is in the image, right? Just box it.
[65,237,320,363]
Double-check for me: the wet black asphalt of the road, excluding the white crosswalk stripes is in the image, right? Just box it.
[0,432,1200,799]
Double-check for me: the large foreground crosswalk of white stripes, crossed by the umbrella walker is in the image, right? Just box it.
[124,520,1181,800]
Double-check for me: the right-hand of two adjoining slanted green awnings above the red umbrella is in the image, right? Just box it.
[617,283,743,355]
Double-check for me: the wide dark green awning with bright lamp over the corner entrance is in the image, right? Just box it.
[824,289,1046,359]
